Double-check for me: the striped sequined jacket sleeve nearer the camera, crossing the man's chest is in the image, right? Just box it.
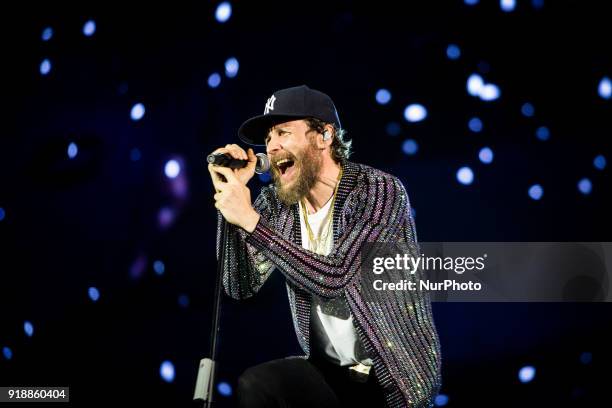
[246,175,409,298]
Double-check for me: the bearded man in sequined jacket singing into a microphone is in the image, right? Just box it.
[208,86,441,407]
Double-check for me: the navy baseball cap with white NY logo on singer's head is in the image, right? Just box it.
[238,85,340,146]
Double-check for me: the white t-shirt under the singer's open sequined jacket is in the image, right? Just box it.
[299,199,372,366]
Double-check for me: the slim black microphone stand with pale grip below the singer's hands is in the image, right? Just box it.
[193,220,228,408]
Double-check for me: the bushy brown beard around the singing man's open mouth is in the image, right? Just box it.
[271,143,322,205]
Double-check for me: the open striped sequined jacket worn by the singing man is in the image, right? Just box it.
[217,161,441,407]
